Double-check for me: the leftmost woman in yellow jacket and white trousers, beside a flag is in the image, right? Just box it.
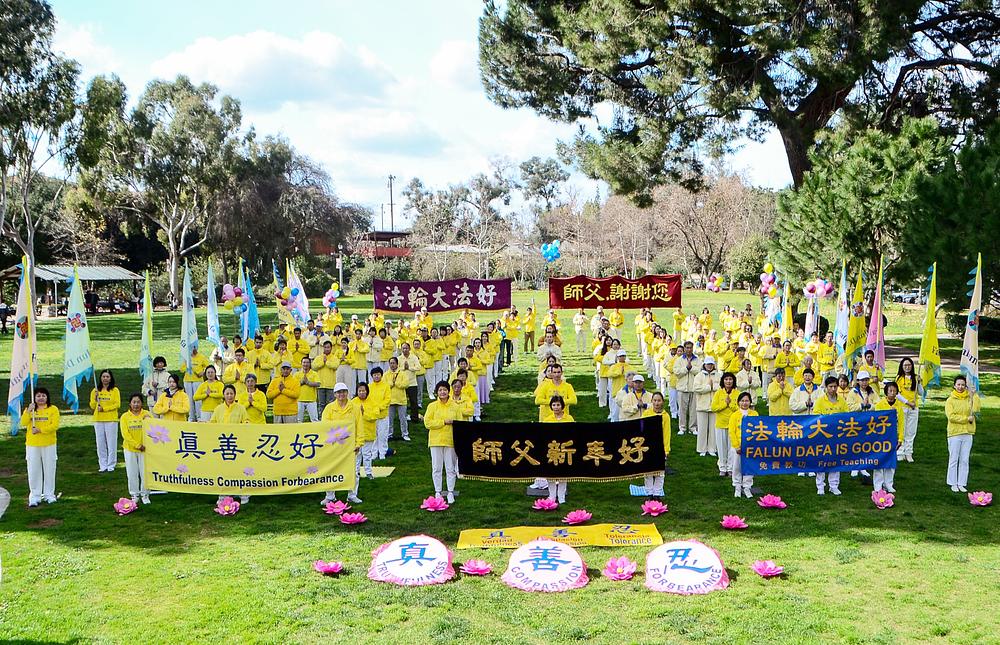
[21,387,59,506]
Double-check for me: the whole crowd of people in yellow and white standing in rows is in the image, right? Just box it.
[21,305,980,506]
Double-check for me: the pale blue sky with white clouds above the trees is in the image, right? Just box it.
[52,0,790,229]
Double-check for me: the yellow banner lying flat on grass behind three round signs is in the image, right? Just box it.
[458,524,663,549]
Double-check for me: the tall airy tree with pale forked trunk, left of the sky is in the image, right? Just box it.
[81,76,241,294]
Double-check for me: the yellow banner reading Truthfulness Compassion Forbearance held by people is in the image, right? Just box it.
[143,418,355,495]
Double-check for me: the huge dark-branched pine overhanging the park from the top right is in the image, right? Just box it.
[479,0,1000,204]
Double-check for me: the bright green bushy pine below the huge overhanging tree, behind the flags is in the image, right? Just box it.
[771,118,952,284]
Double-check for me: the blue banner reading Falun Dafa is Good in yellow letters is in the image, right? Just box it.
[740,410,899,475]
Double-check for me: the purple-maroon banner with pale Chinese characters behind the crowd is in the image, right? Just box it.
[373,278,511,313]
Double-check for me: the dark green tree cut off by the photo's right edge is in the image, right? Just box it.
[900,123,1000,311]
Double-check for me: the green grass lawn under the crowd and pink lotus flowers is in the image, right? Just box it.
[0,292,1000,644]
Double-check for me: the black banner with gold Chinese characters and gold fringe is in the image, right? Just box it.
[453,416,665,482]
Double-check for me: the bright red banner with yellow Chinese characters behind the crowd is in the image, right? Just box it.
[549,274,681,309]
